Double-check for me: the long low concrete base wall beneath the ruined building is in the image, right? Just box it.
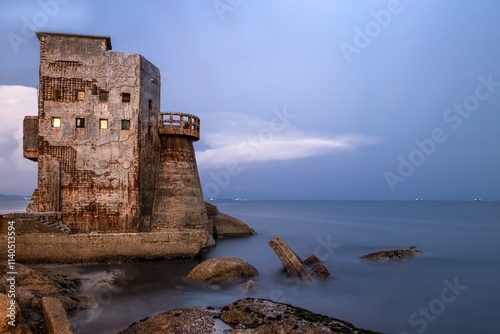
[0,229,210,263]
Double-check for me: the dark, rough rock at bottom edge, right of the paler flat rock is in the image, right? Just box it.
[220,298,375,334]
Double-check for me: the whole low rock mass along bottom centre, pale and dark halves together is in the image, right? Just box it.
[119,298,377,334]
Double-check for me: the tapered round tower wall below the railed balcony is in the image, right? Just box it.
[152,135,209,231]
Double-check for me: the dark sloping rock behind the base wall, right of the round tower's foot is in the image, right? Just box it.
[205,202,256,239]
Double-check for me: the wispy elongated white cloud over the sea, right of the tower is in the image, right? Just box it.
[196,109,380,168]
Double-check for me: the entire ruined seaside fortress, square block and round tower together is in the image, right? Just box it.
[24,32,209,233]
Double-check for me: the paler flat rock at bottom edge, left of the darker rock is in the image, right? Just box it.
[118,306,231,334]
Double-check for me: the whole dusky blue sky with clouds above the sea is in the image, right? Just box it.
[0,0,500,200]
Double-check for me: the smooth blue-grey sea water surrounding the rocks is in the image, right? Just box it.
[1,201,500,334]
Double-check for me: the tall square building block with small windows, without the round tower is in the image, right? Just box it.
[30,33,160,233]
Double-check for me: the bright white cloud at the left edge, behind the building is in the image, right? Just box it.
[0,86,38,195]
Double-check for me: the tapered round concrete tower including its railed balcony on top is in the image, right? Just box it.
[151,112,209,231]
